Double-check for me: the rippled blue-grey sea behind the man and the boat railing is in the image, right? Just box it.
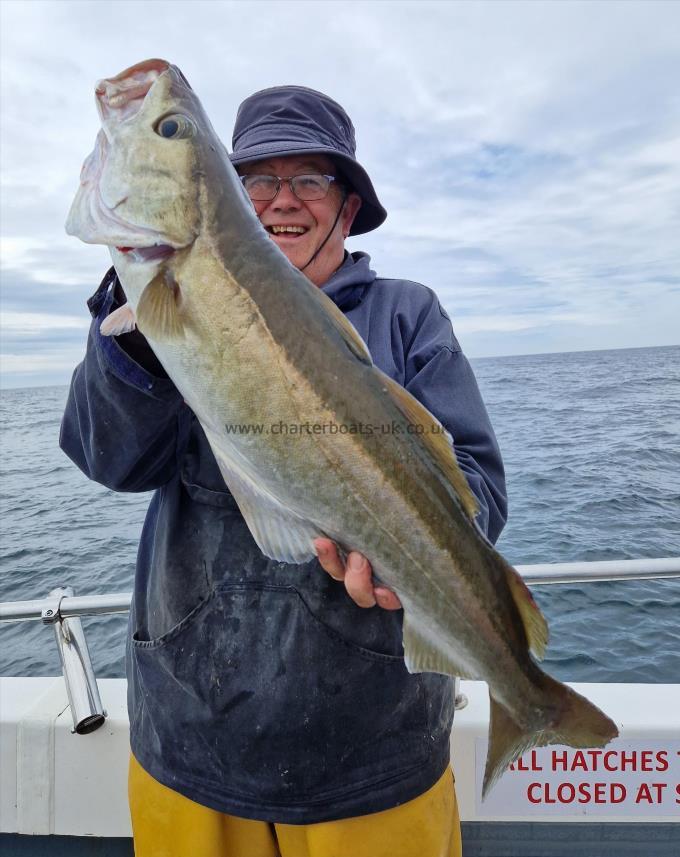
[0,346,680,683]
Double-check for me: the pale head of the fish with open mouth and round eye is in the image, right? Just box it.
[66,59,225,267]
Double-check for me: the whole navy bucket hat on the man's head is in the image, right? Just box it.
[229,86,387,235]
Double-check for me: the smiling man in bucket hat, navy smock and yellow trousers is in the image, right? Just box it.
[62,86,505,857]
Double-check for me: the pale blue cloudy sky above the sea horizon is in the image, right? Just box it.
[0,0,680,387]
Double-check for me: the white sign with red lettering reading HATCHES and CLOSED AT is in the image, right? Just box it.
[475,738,680,819]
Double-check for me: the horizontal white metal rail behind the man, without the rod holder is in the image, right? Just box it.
[0,557,680,622]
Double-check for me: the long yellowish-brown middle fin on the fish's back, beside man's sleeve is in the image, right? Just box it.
[382,374,479,520]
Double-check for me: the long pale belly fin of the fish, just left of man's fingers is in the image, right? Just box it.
[206,432,326,563]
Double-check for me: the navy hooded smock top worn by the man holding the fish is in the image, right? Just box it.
[61,253,506,824]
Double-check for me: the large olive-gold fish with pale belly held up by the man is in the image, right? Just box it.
[66,60,618,794]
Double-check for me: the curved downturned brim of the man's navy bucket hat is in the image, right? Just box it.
[229,140,387,235]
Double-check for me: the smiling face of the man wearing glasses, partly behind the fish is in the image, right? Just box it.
[239,155,361,286]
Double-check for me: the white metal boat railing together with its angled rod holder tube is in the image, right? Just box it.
[0,557,680,734]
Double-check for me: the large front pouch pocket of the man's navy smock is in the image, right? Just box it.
[131,581,432,805]
